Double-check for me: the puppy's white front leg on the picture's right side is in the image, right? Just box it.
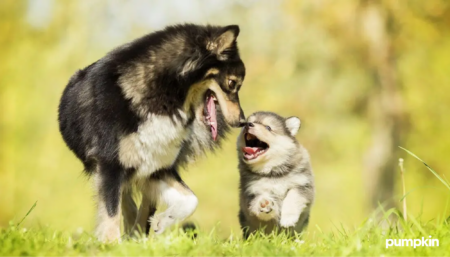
[280,188,309,228]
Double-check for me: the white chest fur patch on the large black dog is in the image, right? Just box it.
[119,112,190,177]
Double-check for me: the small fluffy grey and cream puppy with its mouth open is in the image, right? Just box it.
[237,112,314,238]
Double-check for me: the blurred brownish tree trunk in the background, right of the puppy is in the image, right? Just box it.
[357,0,407,208]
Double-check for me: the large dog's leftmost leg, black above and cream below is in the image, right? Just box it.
[95,162,124,242]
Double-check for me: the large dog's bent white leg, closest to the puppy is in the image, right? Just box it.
[150,169,198,234]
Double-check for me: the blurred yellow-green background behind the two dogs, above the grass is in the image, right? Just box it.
[0,0,450,236]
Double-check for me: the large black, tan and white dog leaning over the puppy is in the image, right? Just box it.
[59,24,245,241]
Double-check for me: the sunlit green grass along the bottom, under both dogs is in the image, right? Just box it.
[0,149,450,257]
